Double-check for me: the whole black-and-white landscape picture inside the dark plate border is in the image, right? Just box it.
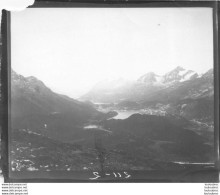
[6,7,216,181]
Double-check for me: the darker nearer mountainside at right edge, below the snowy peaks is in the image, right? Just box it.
[142,69,214,124]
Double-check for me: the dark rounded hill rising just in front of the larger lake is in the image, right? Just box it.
[99,114,213,162]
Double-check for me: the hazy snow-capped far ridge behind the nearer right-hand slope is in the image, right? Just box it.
[80,66,213,103]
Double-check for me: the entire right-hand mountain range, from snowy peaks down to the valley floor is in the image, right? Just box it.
[81,66,214,125]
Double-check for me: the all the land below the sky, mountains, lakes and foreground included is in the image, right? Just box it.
[10,67,214,172]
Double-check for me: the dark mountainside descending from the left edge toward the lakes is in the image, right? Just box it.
[11,71,103,141]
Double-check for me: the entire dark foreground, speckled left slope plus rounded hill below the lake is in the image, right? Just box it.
[10,114,213,171]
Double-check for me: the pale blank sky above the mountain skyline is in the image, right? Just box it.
[11,8,213,98]
